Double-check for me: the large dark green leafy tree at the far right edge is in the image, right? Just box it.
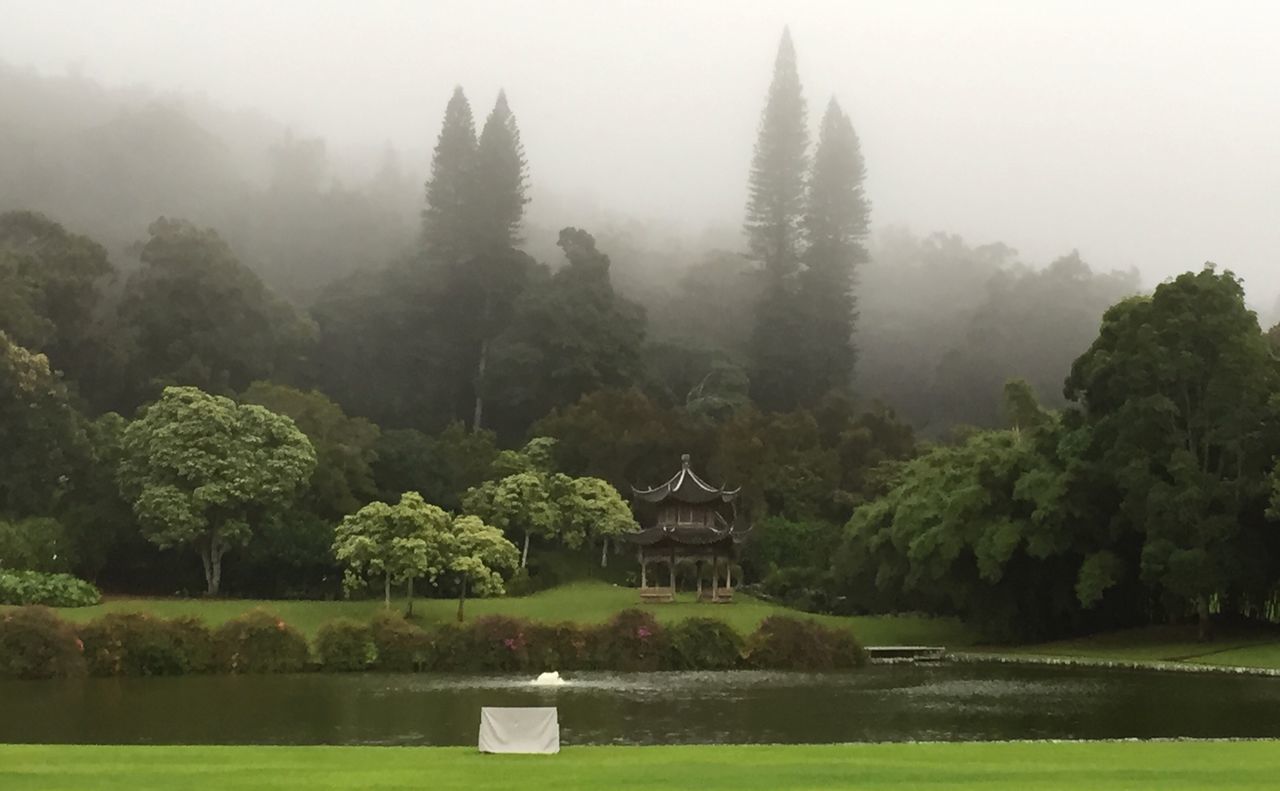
[1066,268,1280,639]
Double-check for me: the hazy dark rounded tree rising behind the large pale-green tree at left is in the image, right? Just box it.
[120,218,312,399]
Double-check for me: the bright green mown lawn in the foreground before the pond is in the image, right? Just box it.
[0,741,1280,791]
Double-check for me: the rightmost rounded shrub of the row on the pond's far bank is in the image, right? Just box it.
[746,616,867,671]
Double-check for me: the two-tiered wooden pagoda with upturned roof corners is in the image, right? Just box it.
[626,453,748,604]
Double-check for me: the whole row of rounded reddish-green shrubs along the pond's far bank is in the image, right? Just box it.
[0,607,865,678]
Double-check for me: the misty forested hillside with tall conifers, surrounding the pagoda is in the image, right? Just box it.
[0,35,1280,639]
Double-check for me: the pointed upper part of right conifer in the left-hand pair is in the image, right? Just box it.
[474,91,529,251]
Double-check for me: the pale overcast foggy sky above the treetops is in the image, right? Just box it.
[0,0,1280,295]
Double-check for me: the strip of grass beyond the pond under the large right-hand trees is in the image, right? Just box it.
[991,626,1280,669]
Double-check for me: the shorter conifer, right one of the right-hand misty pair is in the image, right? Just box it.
[799,99,870,399]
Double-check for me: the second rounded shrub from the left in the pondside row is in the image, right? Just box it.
[78,613,214,676]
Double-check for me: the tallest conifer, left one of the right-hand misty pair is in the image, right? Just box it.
[745,29,809,410]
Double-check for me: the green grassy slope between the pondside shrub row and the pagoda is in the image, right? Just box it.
[40,582,973,646]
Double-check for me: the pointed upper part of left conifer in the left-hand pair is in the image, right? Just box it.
[422,87,476,262]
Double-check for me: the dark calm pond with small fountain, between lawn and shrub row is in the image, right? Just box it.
[0,664,1280,745]
